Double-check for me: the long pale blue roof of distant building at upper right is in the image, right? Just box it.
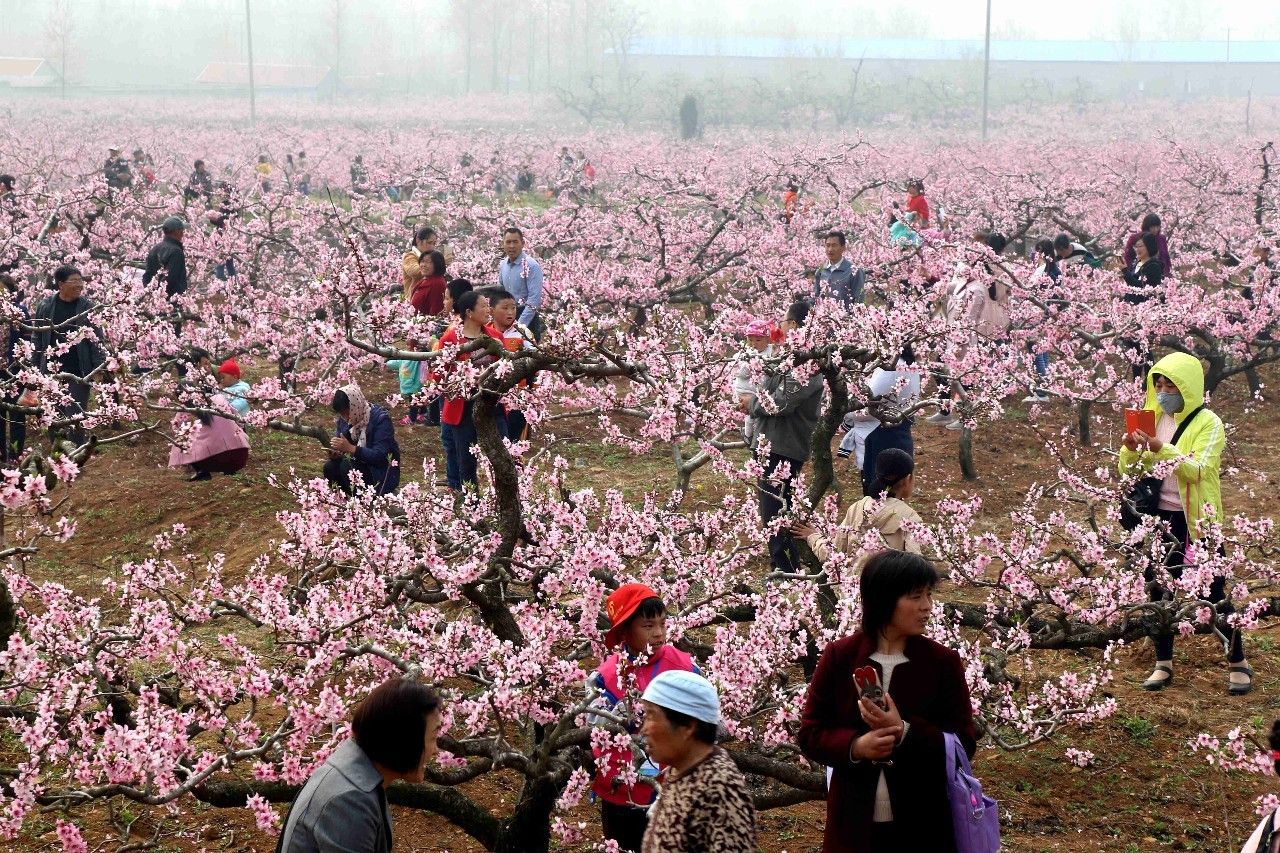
[627,36,1280,63]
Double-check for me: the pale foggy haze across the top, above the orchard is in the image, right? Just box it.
[0,0,1280,126]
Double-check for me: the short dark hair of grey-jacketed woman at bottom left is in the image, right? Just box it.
[351,676,440,774]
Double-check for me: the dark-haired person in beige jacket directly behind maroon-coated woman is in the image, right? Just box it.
[791,447,923,562]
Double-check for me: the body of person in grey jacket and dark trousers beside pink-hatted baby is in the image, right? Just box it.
[739,373,823,571]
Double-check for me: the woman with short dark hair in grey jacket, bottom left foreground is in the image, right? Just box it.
[276,678,442,853]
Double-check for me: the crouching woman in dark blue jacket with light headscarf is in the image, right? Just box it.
[324,383,399,494]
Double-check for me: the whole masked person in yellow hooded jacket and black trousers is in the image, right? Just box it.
[1120,352,1253,695]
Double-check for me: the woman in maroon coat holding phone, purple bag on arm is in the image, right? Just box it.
[797,551,975,853]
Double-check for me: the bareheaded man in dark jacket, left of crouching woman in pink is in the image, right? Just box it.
[32,266,106,444]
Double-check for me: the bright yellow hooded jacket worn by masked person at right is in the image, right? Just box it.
[1120,352,1226,537]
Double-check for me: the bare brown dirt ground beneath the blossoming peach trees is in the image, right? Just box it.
[12,361,1280,853]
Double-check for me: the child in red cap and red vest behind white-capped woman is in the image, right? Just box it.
[589,584,699,850]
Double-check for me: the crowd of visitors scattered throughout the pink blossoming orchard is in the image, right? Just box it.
[3,149,1261,853]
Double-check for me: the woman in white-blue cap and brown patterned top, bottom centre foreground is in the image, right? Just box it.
[640,670,756,853]
